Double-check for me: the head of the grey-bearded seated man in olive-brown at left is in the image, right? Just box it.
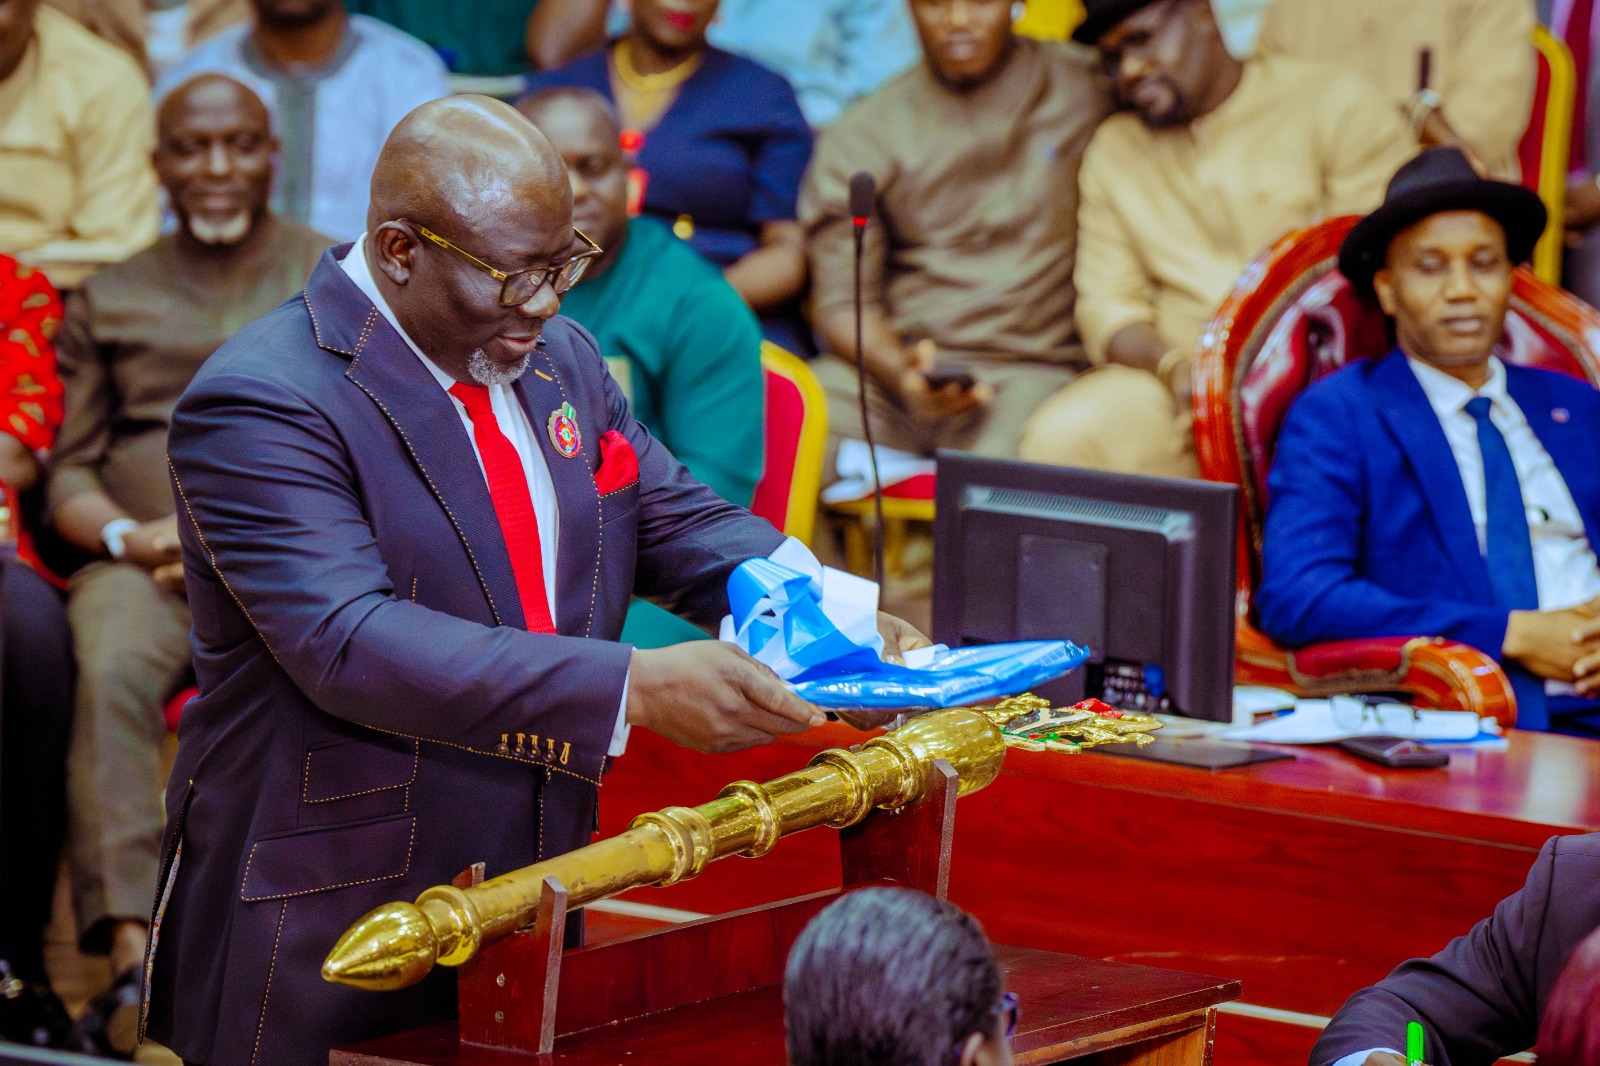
[154,74,278,245]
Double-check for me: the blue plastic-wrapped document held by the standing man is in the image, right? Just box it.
[722,549,1090,711]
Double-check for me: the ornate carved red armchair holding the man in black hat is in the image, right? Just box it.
[1194,218,1600,725]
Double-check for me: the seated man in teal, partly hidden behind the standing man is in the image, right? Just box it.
[520,88,765,648]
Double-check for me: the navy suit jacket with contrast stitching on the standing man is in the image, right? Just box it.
[149,248,782,1066]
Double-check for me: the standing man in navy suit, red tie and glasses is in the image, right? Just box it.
[146,96,923,1066]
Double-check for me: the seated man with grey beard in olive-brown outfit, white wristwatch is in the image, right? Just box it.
[50,74,330,1050]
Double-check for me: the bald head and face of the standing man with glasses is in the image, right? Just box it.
[366,96,576,384]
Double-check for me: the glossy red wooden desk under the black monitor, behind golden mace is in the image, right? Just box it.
[588,725,1600,1066]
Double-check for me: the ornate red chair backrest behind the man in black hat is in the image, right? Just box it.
[1194,216,1600,592]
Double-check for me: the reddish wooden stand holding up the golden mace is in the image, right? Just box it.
[330,759,1238,1066]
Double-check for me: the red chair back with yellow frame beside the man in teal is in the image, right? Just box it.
[750,341,827,544]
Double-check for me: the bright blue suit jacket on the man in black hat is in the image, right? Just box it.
[1254,351,1600,656]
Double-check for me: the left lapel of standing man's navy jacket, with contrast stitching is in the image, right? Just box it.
[306,248,523,627]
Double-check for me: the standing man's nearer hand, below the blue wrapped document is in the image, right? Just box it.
[627,631,825,752]
